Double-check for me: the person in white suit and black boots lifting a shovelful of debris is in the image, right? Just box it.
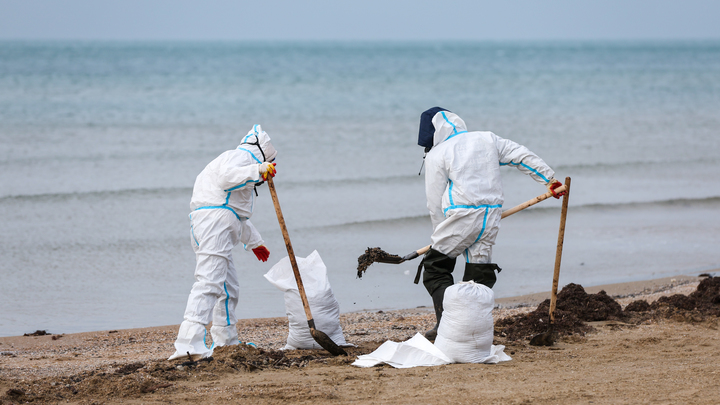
[416,107,564,340]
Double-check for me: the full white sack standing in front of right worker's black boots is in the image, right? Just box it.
[435,281,510,363]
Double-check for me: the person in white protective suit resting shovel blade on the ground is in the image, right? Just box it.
[168,125,277,360]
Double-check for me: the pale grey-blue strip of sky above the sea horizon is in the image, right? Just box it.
[0,0,720,40]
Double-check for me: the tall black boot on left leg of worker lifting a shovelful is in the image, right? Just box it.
[422,249,455,341]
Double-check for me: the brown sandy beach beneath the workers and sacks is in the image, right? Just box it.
[0,276,720,404]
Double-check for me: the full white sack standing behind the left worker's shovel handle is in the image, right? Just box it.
[265,250,347,350]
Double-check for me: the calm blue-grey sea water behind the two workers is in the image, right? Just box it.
[0,42,720,336]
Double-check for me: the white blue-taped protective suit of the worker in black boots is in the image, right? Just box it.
[425,111,555,263]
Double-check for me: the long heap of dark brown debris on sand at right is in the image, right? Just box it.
[495,277,720,341]
